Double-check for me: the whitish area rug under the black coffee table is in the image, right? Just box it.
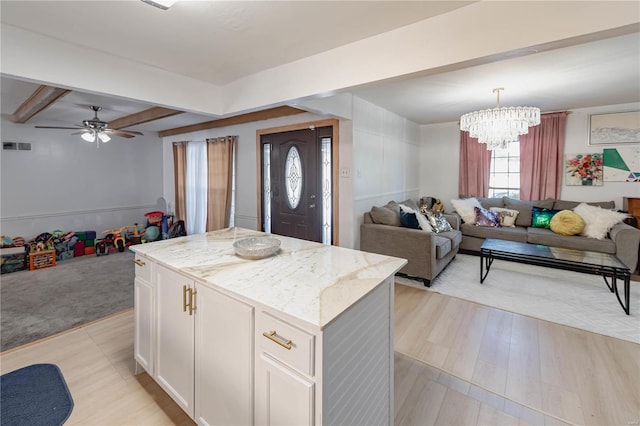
[396,254,640,343]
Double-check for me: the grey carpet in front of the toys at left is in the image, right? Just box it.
[0,251,135,351]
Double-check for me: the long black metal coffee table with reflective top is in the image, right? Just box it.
[480,238,631,315]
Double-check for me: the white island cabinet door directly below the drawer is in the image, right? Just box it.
[255,352,315,425]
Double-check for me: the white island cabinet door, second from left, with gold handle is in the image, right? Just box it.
[155,266,195,418]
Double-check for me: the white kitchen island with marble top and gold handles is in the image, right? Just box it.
[131,228,406,425]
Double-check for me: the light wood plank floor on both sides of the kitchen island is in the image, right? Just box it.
[0,285,640,426]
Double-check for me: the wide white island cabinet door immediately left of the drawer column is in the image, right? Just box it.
[195,285,254,425]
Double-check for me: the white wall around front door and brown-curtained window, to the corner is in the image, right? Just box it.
[163,95,420,248]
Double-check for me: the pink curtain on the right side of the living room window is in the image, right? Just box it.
[520,112,567,200]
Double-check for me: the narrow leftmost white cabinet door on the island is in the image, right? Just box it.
[133,276,155,376]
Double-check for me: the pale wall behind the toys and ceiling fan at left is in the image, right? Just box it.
[0,115,162,239]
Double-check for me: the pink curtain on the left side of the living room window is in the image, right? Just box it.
[458,131,491,197]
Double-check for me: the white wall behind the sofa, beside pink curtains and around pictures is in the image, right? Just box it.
[420,103,640,210]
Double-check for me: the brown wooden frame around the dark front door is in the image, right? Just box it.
[256,118,340,246]
